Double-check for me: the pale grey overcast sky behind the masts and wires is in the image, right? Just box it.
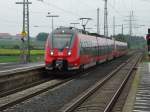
[0,0,150,36]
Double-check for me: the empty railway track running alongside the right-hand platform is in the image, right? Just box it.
[59,54,142,112]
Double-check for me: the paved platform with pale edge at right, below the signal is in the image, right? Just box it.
[122,62,150,112]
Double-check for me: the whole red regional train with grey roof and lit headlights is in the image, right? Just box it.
[45,27,127,71]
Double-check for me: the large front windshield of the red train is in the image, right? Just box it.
[52,34,73,50]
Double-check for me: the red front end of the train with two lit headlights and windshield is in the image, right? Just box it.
[45,28,79,71]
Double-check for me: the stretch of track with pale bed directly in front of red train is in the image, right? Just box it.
[0,78,74,111]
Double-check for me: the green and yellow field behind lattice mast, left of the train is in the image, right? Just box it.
[0,38,45,63]
